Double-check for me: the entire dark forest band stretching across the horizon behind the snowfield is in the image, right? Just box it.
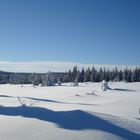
[0,66,140,84]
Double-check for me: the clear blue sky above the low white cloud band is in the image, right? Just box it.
[0,0,140,65]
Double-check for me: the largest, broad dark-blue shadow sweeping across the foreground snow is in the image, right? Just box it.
[0,106,140,140]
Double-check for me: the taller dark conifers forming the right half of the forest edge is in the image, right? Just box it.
[63,66,140,82]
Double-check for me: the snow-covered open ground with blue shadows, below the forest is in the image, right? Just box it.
[0,82,140,140]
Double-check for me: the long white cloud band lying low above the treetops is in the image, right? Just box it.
[0,61,136,73]
